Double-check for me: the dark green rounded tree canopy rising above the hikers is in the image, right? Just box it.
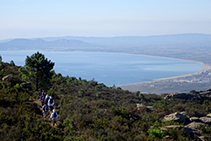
[20,52,54,90]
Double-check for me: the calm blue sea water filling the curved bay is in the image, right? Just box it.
[0,51,203,86]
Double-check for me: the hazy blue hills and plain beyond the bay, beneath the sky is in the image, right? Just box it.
[0,34,211,65]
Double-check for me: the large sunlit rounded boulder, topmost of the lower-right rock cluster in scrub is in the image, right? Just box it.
[162,112,189,122]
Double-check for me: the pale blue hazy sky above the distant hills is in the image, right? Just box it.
[0,0,211,40]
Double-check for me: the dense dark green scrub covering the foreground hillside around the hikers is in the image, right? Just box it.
[0,60,211,141]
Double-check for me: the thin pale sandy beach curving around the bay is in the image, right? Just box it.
[117,58,211,89]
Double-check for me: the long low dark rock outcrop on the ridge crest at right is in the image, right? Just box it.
[164,93,201,100]
